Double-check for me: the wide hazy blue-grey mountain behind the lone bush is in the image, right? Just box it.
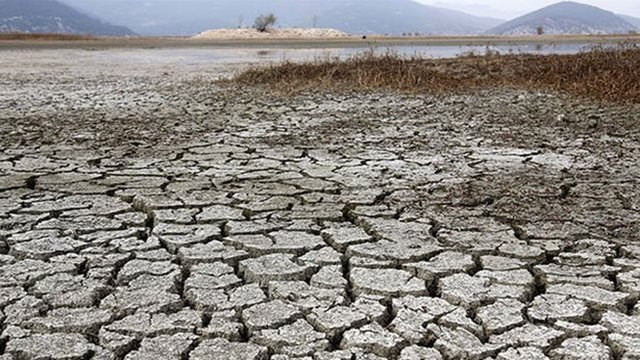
[64,0,503,35]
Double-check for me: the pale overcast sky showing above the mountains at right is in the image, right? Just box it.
[416,0,640,19]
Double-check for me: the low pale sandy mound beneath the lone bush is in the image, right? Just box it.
[194,29,349,39]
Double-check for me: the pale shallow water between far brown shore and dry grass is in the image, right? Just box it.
[0,44,612,84]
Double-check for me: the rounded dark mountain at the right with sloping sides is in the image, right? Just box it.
[487,1,638,35]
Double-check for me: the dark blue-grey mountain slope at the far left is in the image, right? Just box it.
[0,0,135,36]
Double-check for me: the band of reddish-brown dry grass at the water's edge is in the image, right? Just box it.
[230,45,640,103]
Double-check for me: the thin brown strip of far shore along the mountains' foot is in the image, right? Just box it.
[0,35,640,50]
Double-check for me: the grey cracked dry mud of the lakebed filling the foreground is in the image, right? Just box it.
[0,51,640,360]
